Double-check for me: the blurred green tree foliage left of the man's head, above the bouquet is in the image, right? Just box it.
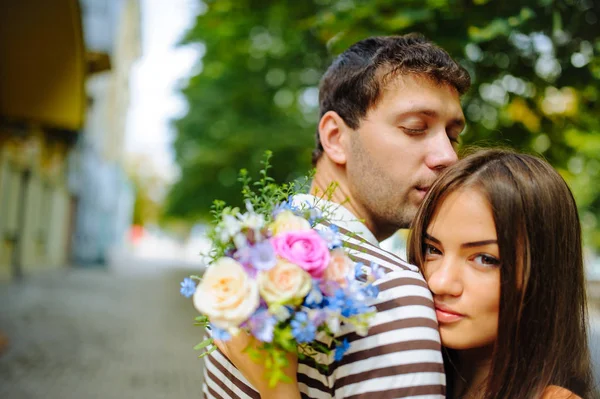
[167,0,329,216]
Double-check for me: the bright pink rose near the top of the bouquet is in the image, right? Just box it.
[271,229,329,278]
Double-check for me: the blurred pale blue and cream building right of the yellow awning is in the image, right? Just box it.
[69,0,141,265]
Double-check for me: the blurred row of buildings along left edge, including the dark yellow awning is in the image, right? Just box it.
[0,0,140,279]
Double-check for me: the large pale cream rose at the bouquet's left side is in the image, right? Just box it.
[194,258,260,330]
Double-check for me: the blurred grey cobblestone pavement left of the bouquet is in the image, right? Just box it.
[0,261,202,399]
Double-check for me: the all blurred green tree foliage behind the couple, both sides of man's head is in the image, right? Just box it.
[167,0,600,248]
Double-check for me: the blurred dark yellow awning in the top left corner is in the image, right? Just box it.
[0,0,88,130]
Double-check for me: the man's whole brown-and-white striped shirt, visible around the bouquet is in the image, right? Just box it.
[203,195,446,399]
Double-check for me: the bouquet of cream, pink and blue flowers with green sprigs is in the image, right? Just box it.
[181,152,380,386]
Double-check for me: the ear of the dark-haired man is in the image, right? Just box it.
[319,111,351,165]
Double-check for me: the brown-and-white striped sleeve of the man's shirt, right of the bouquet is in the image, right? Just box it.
[332,231,446,399]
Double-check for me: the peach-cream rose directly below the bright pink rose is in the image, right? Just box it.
[258,259,312,305]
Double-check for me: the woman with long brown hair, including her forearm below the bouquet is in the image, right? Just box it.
[219,150,592,399]
